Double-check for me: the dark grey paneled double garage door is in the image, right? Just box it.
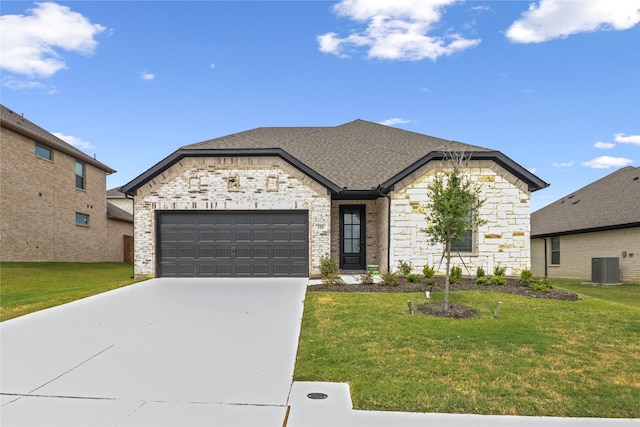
[156,211,309,277]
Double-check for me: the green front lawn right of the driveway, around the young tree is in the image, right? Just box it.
[294,282,640,418]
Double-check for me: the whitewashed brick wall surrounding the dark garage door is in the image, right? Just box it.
[134,156,331,277]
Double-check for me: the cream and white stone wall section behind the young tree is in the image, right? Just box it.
[390,160,531,275]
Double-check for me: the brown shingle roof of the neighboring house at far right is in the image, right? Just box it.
[531,166,640,238]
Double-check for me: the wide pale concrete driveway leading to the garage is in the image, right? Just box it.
[0,279,307,426]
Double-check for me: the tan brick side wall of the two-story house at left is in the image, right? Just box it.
[0,127,107,262]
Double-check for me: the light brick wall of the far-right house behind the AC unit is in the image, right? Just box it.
[531,227,640,283]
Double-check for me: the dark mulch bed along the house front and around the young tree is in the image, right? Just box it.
[307,277,580,319]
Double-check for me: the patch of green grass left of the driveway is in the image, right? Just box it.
[0,262,140,321]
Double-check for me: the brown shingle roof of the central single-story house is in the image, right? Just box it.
[122,120,548,194]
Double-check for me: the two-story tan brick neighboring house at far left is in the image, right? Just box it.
[0,106,133,262]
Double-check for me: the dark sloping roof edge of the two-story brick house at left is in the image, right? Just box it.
[0,105,116,174]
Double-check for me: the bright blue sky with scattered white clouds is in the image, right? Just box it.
[0,0,640,211]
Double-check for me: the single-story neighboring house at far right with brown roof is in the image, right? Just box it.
[531,166,640,283]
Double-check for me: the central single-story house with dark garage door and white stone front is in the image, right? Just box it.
[121,120,548,277]
